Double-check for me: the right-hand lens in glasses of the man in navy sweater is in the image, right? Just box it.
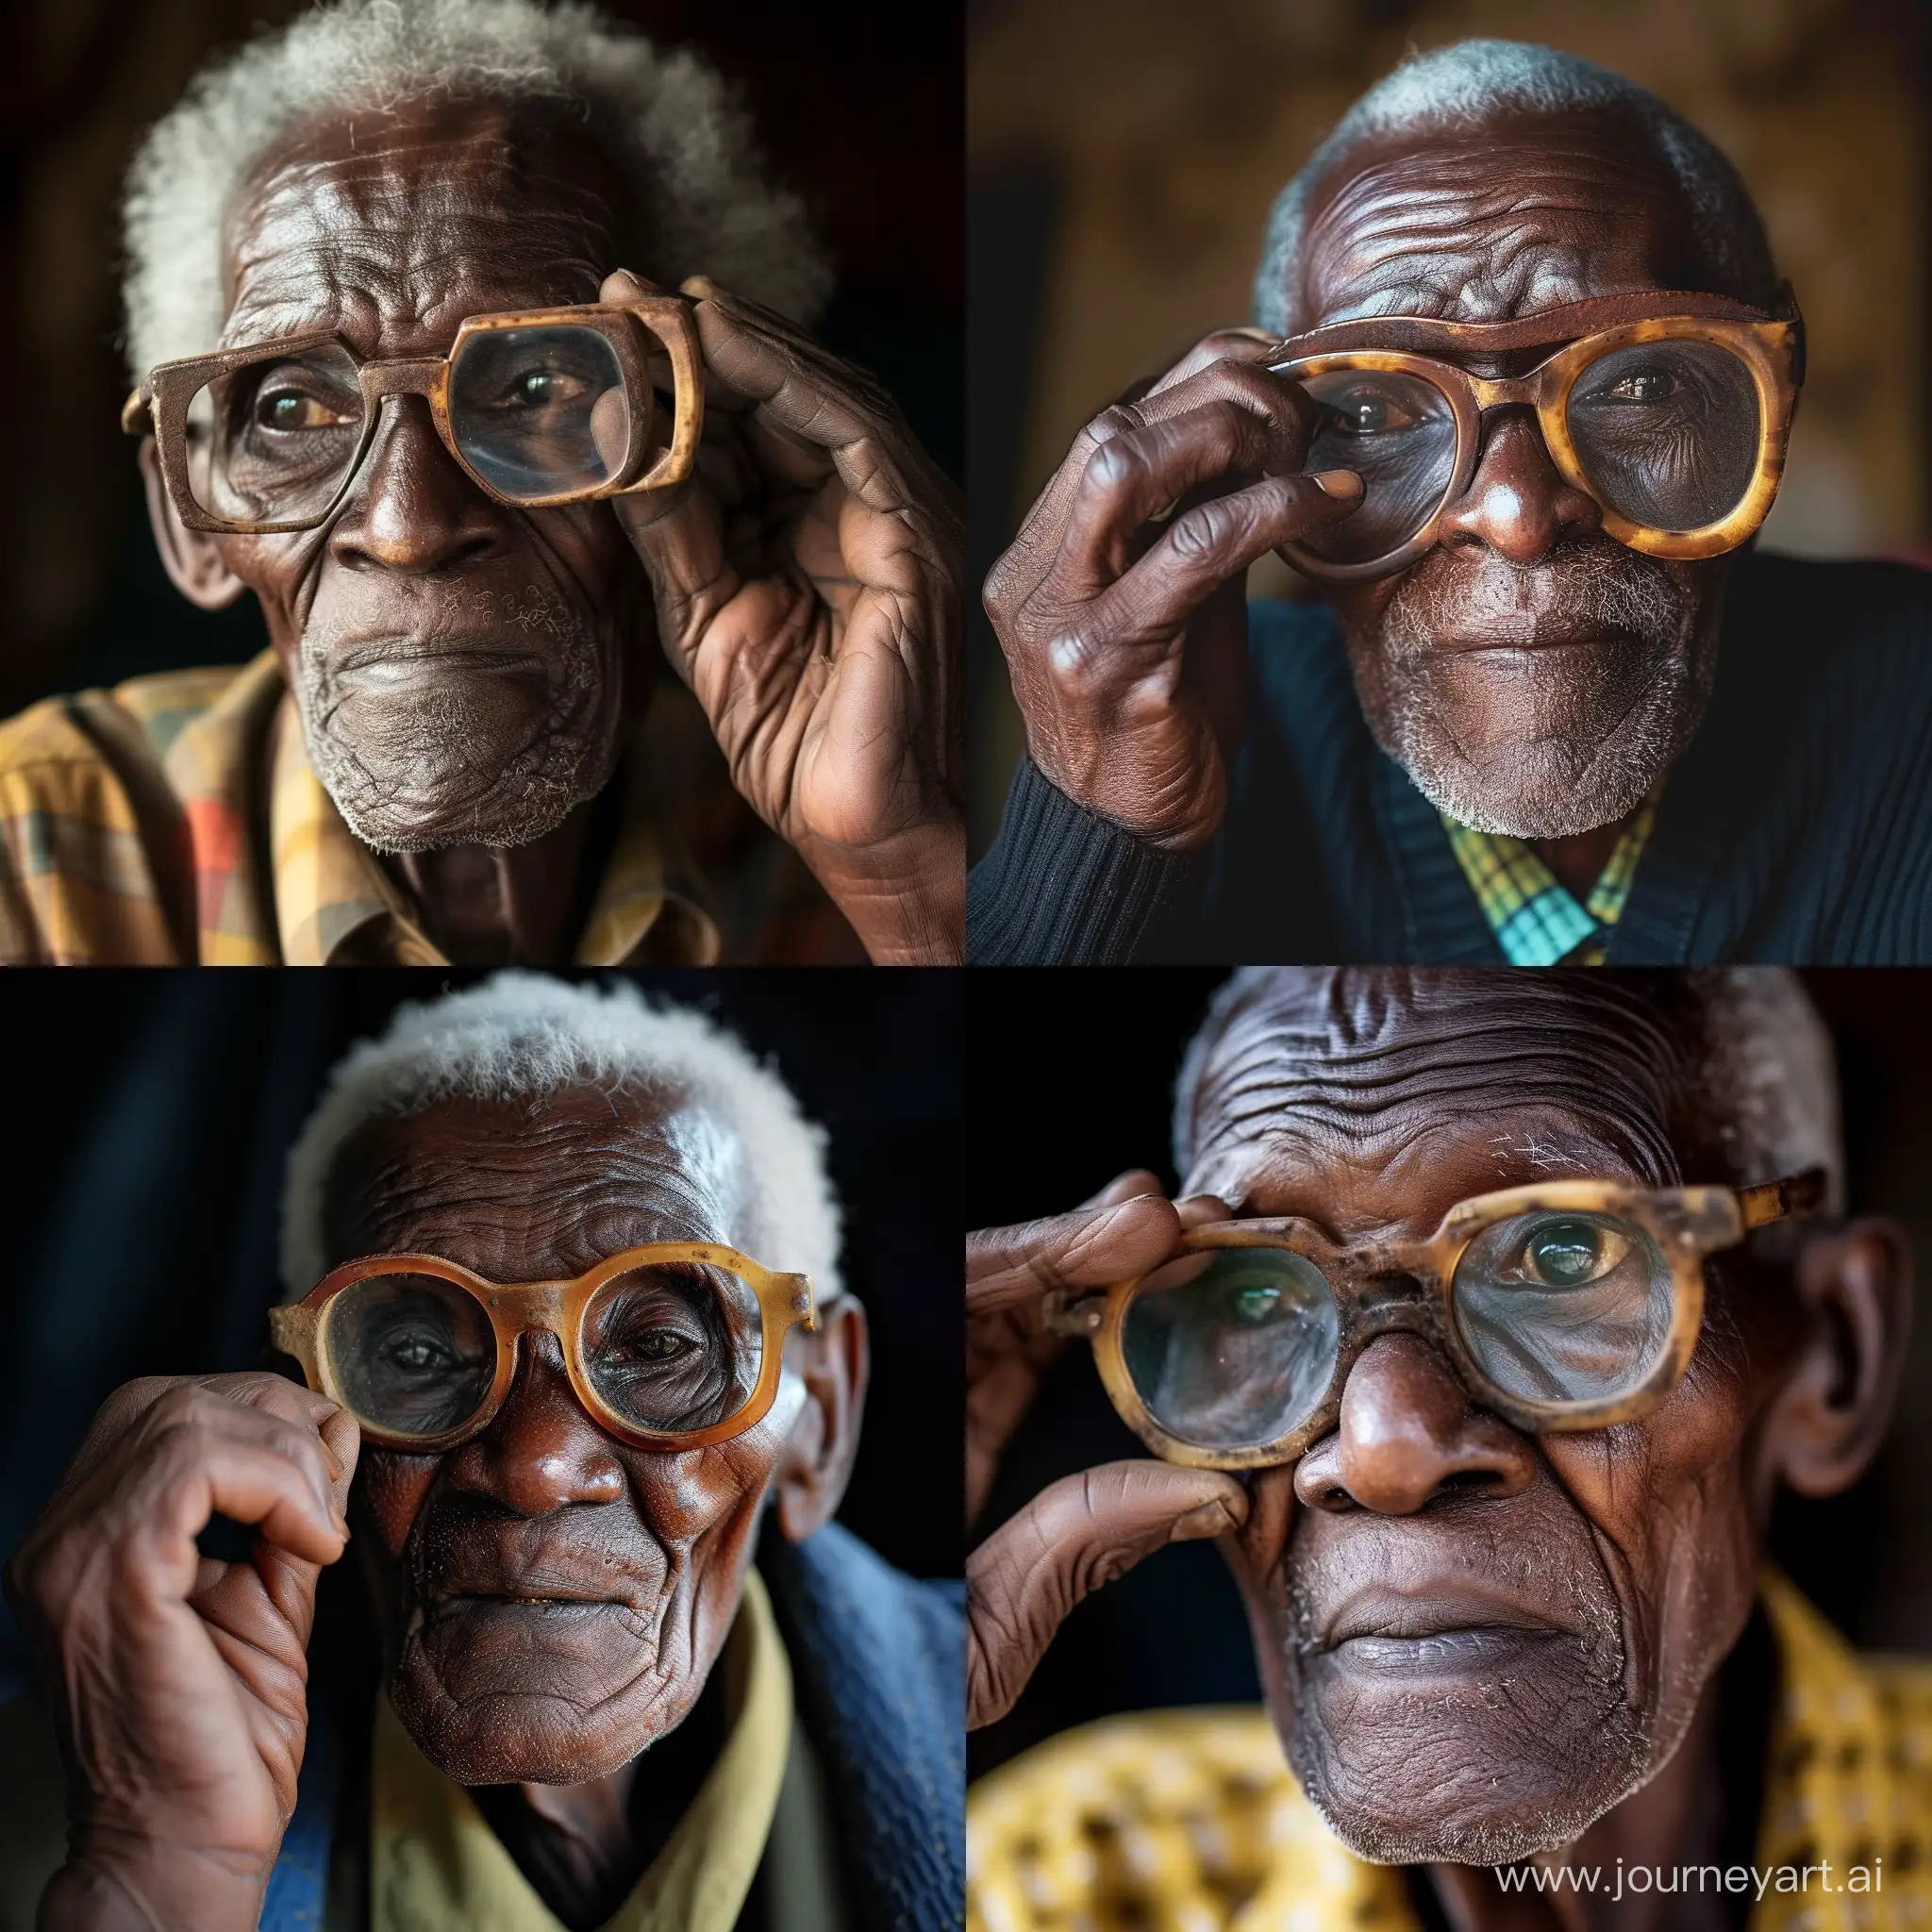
[1569,341,1762,531]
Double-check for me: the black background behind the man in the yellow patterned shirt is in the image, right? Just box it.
[966,970,1932,1777]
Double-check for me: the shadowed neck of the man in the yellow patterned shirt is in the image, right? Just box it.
[1427,1613,1777,1932]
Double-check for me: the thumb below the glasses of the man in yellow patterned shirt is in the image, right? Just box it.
[966,1462,1248,1729]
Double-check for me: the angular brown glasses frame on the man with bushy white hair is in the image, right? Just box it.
[122,295,706,537]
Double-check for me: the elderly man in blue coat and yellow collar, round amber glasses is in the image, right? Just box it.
[0,975,962,1932]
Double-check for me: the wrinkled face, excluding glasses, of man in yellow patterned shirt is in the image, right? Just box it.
[1184,974,1793,1864]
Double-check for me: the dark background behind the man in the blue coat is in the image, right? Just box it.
[0,970,966,1702]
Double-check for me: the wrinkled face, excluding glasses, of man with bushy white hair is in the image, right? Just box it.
[210,105,643,852]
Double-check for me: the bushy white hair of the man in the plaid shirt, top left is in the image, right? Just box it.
[124,0,831,380]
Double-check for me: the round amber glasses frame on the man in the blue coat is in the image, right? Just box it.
[269,1241,819,1455]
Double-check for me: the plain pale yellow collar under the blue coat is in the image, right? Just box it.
[369,1571,792,1932]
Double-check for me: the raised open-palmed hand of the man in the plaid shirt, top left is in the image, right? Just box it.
[603,273,966,964]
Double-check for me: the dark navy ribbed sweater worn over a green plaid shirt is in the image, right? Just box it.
[966,553,1932,966]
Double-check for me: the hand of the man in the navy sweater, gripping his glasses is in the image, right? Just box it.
[985,330,1362,852]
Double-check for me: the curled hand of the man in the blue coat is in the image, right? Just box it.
[6,1374,359,1932]
